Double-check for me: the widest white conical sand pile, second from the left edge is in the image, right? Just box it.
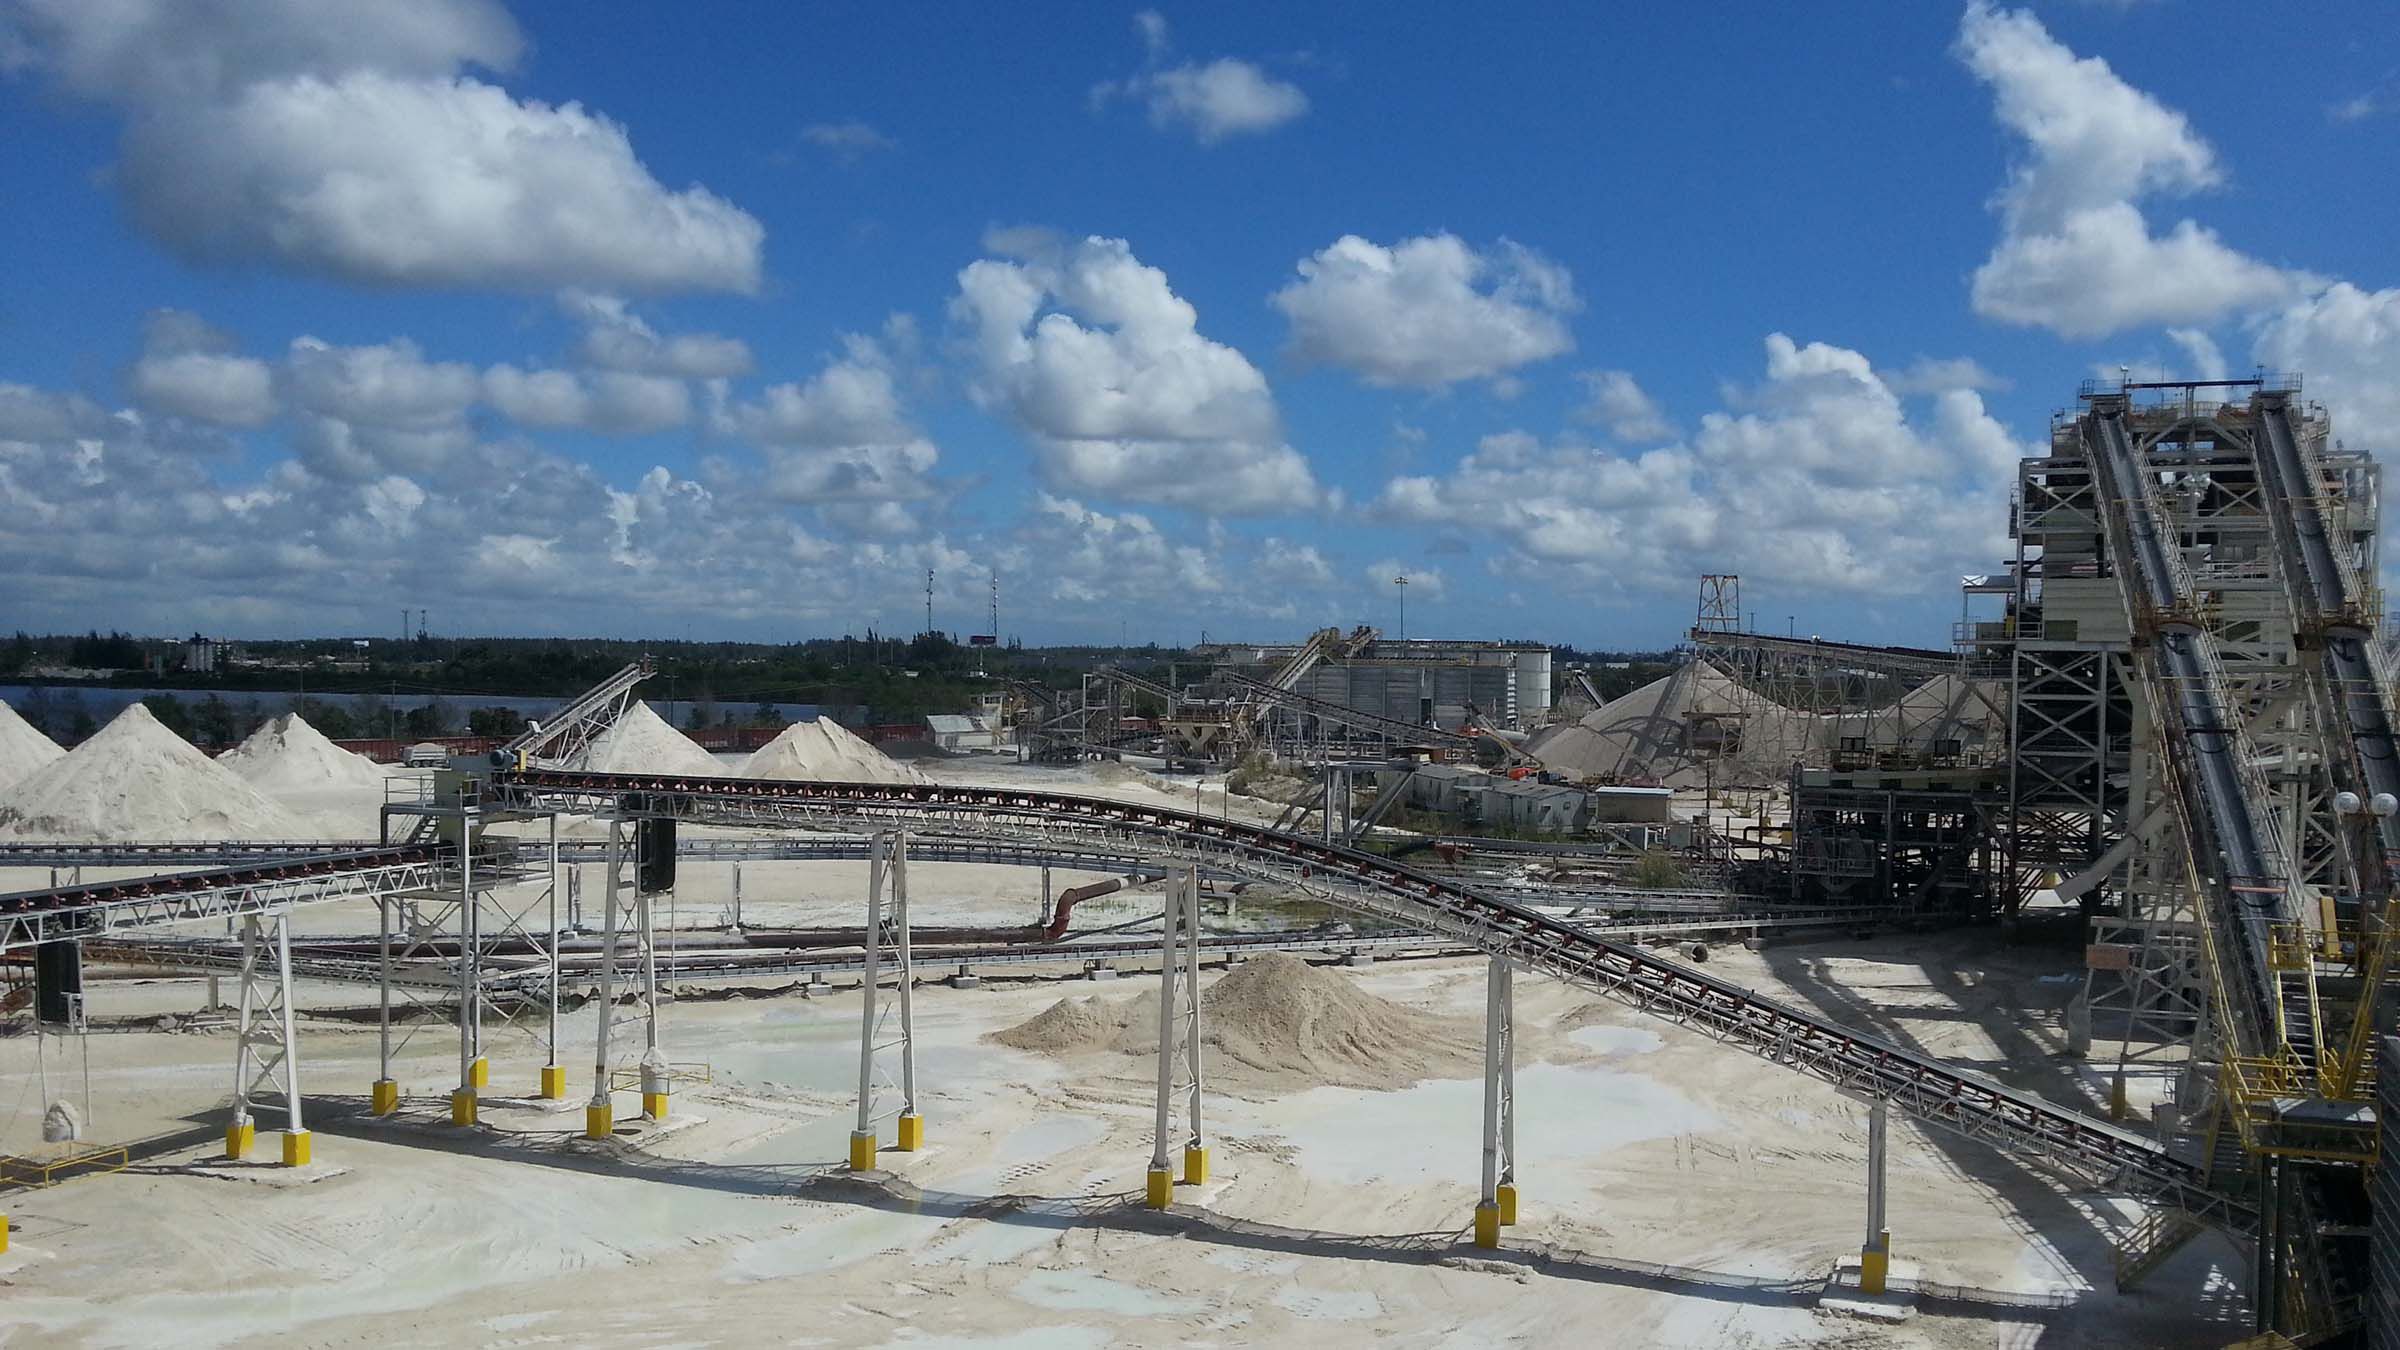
[0,704,310,841]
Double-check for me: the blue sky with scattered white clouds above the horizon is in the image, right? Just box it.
[0,0,2400,646]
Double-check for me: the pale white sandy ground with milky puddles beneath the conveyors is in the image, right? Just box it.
[0,761,2239,1348]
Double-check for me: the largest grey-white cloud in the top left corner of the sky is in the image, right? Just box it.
[0,0,766,293]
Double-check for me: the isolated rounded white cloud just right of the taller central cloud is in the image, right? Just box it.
[1270,233,1582,389]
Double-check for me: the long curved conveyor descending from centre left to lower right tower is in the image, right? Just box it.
[490,771,2256,1232]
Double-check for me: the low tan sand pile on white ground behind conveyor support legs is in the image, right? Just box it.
[991,951,1481,1091]
